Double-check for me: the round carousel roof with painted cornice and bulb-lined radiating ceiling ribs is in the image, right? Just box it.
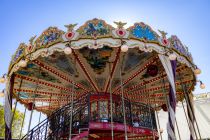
[8,19,196,114]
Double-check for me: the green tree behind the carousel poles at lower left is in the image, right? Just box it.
[0,105,23,138]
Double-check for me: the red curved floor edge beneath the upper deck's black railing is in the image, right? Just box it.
[72,122,158,140]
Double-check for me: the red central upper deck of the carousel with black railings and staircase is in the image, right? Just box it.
[22,94,158,140]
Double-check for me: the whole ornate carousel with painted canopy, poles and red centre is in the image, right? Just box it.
[1,19,205,140]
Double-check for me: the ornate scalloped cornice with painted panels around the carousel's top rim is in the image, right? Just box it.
[8,19,195,75]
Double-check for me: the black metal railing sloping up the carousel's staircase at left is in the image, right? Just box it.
[22,93,88,140]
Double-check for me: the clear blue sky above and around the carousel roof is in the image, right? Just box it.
[0,0,210,135]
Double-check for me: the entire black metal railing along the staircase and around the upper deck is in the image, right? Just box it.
[22,95,157,140]
